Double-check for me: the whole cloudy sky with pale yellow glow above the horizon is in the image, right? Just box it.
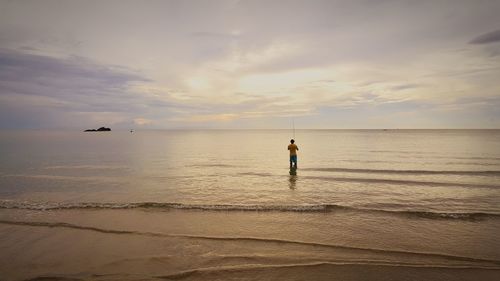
[0,0,500,129]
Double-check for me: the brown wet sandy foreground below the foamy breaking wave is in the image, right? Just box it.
[0,207,500,280]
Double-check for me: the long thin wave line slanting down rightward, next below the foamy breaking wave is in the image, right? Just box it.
[0,220,500,265]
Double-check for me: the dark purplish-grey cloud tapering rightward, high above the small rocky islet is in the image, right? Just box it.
[0,47,149,99]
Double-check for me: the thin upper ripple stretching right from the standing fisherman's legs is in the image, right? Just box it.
[302,168,500,176]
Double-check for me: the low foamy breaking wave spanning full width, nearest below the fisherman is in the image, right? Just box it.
[0,200,500,221]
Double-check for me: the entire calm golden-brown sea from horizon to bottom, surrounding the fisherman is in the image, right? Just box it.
[0,130,500,280]
